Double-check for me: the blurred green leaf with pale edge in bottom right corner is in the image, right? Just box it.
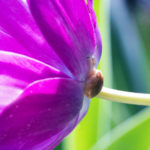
[92,108,150,150]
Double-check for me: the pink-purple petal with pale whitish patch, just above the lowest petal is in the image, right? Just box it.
[0,51,67,106]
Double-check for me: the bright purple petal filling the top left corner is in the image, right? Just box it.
[0,0,69,74]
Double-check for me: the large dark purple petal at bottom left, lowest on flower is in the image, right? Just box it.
[0,78,83,150]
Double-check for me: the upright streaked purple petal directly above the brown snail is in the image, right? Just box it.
[28,0,95,80]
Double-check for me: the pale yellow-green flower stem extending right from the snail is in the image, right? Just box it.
[97,87,150,105]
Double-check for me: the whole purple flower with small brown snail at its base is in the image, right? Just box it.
[0,0,102,150]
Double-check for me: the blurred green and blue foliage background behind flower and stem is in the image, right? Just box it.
[55,0,150,150]
